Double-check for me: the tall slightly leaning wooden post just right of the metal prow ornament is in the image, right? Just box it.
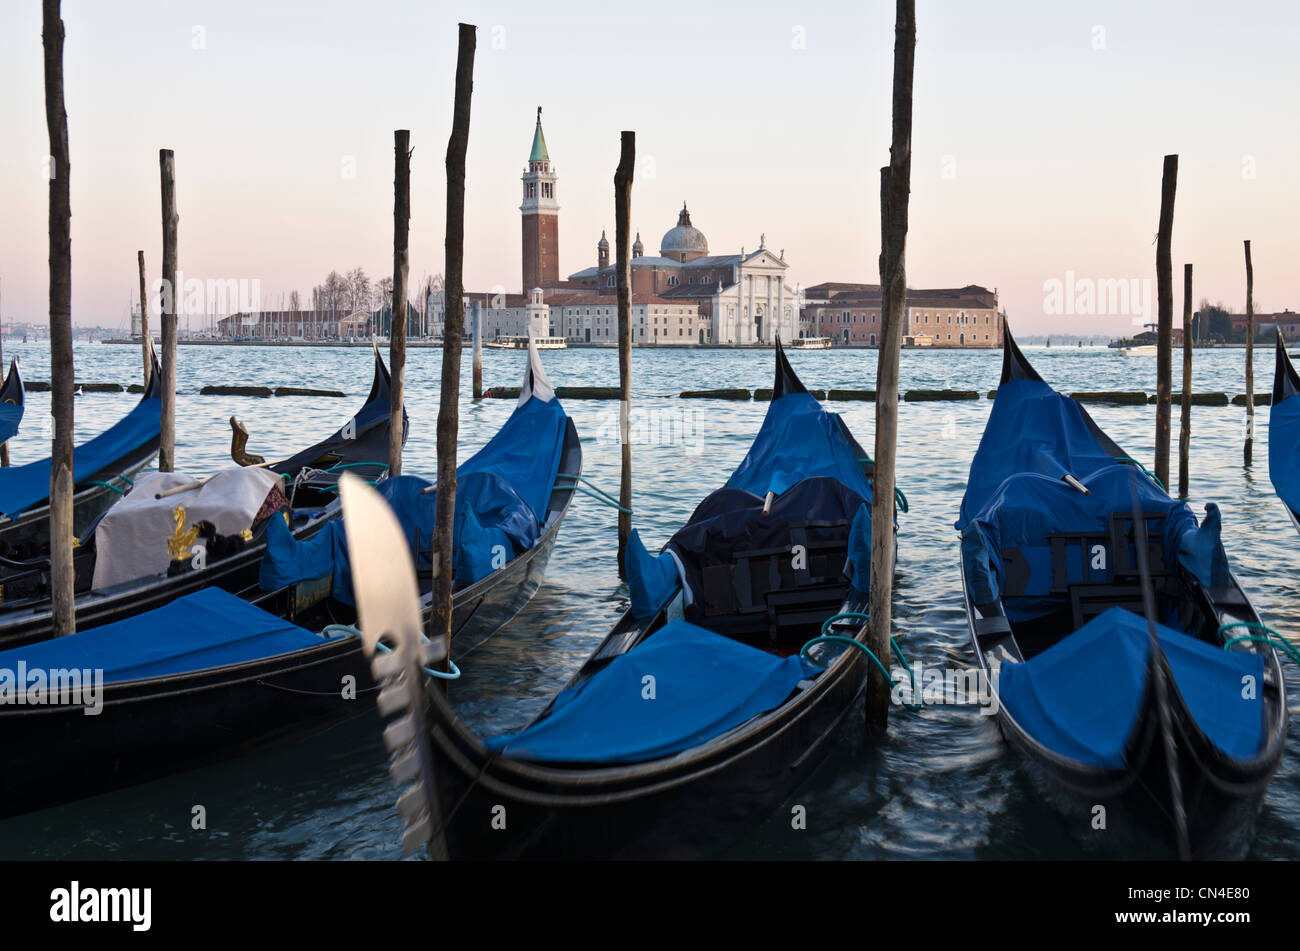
[429,23,475,672]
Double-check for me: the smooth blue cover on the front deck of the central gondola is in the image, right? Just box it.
[485,621,819,763]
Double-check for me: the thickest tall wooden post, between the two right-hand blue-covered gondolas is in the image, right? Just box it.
[867,0,917,735]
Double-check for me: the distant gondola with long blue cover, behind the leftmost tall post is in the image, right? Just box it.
[0,348,163,561]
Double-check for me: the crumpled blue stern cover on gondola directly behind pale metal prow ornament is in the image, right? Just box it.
[259,396,568,604]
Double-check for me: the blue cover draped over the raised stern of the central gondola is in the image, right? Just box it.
[727,392,871,500]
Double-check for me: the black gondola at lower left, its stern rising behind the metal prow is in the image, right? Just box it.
[0,340,582,816]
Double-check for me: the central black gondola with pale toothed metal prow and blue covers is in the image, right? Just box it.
[342,343,899,859]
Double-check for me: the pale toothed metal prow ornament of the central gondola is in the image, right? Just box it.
[339,473,447,860]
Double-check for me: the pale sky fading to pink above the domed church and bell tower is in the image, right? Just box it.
[0,0,1300,333]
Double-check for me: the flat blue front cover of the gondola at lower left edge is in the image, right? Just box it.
[0,587,330,683]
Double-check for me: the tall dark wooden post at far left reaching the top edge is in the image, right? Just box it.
[42,0,77,637]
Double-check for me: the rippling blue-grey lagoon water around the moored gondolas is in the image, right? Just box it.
[0,340,1300,859]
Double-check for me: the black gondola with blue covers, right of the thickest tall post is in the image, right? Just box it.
[957,331,1287,857]
